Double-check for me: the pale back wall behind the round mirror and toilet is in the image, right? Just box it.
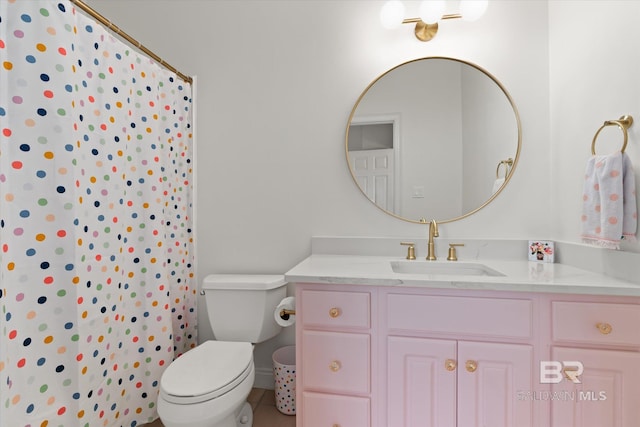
[88,0,556,378]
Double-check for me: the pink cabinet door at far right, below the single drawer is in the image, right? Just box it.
[551,347,640,427]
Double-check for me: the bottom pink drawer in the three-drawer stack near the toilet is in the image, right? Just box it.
[301,392,371,427]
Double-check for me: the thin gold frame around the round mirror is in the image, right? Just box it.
[345,56,522,224]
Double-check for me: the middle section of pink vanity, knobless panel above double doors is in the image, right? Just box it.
[380,288,535,427]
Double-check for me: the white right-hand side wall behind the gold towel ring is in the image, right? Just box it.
[549,0,640,253]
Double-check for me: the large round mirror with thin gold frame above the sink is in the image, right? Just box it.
[346,57,521,223]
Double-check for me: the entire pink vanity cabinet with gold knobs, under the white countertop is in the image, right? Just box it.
[296,283,640,427]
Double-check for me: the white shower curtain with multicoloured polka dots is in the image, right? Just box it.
[0,0,196,427]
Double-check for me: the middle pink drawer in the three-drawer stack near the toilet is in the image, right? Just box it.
[302,331,371,394]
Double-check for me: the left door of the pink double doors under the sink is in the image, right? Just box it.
[387,336,457,427]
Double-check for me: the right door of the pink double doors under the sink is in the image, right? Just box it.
[458,341,532,427]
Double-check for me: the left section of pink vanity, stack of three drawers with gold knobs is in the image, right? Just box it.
[296,285,378,427]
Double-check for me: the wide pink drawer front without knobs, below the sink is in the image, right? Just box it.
[387,294,533,339]
